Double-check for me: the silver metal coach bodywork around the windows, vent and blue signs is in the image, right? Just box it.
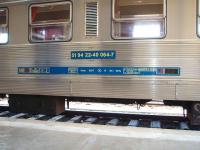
[0,0,200,101]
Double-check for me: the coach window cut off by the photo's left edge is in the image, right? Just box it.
[0,8,8,44]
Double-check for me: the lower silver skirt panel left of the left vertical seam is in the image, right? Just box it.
[0,77,70,96]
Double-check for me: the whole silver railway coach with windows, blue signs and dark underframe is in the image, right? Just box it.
[0,0,200,125]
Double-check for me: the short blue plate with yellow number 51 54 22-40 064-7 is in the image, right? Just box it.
[71,50,116,59]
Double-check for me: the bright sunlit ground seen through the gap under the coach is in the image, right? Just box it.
[0,99,183,116]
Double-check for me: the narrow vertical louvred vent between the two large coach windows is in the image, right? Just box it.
[85,2,98,37]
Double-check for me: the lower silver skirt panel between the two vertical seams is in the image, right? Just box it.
[72,79,175,99]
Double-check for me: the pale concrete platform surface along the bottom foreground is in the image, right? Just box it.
[0,118,200,150]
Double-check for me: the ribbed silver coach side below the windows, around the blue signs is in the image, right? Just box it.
[0,41,200,100]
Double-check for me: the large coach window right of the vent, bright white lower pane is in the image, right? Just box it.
[112,0,166,39]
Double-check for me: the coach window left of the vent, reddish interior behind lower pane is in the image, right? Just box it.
[29,1,72,42]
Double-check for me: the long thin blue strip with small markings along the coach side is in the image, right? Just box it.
[18,67,180,76]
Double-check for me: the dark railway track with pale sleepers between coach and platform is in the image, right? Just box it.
[0,106,200,131]
